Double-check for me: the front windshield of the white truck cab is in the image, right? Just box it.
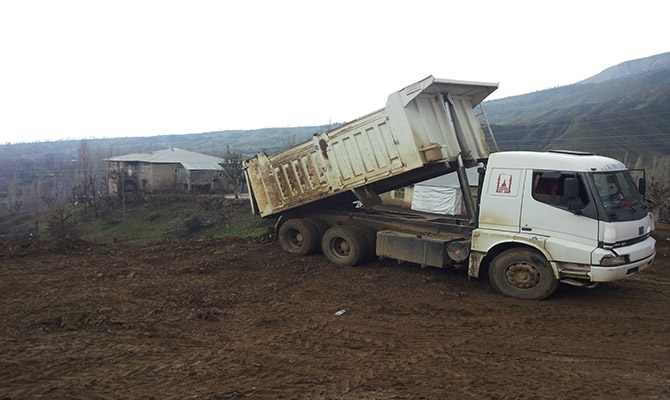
[593,171,647,221]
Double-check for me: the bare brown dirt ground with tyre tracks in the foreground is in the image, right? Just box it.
[0,232,670,400]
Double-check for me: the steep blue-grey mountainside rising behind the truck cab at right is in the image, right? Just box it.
[484,53,670,159]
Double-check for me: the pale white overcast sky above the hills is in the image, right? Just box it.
[0,0,670,144]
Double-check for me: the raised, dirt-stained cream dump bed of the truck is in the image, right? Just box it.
[244,76,497,216]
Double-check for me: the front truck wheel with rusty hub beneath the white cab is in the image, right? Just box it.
[489,249,558,300]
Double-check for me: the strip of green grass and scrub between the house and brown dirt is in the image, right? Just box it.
[0,196,274,245]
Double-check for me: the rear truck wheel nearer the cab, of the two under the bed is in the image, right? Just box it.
[321,226,368,266]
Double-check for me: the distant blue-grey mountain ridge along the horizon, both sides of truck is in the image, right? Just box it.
[0,52,670,164]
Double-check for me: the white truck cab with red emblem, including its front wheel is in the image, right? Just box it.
[469,152,655,298]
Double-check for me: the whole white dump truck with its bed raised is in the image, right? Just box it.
[244,76,655,299]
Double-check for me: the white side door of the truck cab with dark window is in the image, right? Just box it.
[520,170,598,265]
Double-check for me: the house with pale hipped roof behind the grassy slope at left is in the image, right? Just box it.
[105,148,225,195]
